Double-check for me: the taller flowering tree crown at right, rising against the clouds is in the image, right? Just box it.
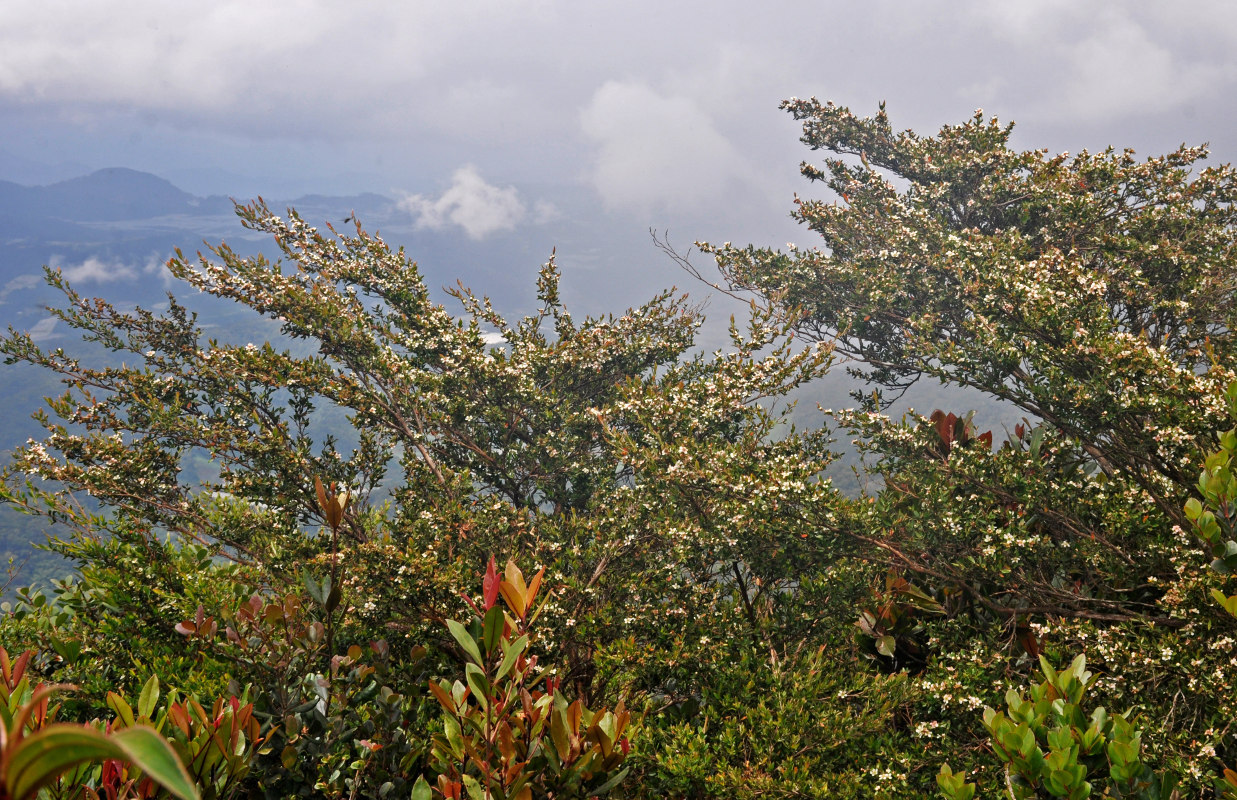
[706,99,1237,529]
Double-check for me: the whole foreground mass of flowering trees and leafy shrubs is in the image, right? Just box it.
[0,100,1237,800]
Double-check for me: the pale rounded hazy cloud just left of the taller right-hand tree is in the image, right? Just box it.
[580,80,756,211]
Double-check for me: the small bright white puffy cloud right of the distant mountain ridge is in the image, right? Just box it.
[400,164,524,239]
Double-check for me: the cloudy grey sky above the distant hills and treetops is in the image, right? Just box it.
[0,0,1237,310]
